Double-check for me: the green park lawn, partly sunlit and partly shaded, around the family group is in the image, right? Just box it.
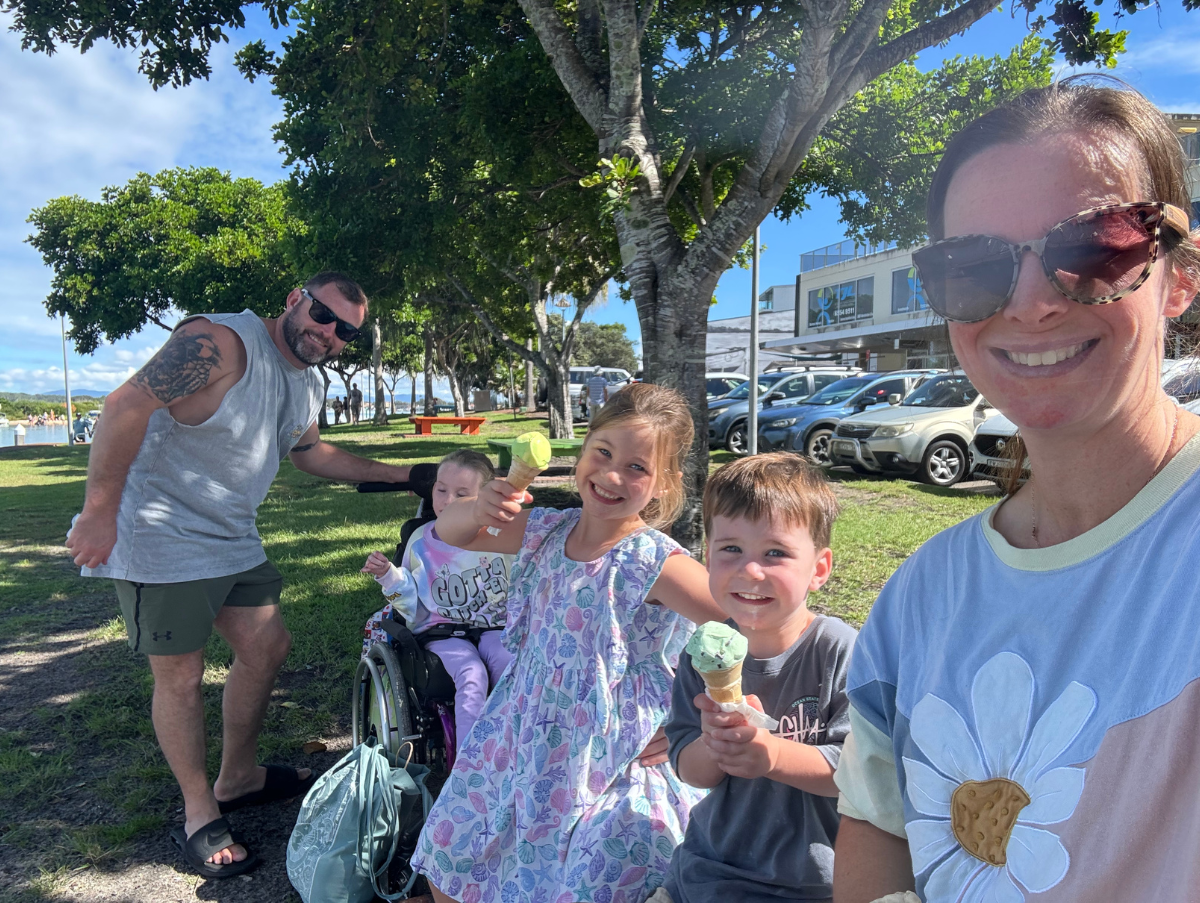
[0,415,992,897]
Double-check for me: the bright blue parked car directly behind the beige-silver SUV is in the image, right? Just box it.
[758,370,942,466]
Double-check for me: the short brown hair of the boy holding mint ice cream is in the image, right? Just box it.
[704,452,838,549]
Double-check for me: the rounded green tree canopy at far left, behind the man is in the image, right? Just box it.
[29,168,302,354]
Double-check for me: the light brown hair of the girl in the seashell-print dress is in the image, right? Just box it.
[581,383,696,530]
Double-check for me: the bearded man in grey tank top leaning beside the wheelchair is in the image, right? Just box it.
[67,273,409,878]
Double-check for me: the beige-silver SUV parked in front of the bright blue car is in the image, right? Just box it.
[829,372,996,486]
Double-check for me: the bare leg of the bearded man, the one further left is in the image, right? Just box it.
[148,650,246,865]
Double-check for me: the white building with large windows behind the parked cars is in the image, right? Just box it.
[763,114,1200,370]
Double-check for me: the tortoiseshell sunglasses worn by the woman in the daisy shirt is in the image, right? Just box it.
[912,203,1188,323]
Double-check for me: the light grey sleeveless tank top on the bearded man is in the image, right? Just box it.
[83,310,324,584]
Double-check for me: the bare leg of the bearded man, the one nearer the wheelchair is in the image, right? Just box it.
[212,605,311,800]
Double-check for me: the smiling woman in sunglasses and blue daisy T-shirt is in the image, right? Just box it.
[834,79,1200,903]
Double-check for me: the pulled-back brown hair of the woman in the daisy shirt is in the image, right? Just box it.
[926,76,1200,495]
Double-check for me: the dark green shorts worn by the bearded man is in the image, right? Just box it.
[113,561,283,656]
